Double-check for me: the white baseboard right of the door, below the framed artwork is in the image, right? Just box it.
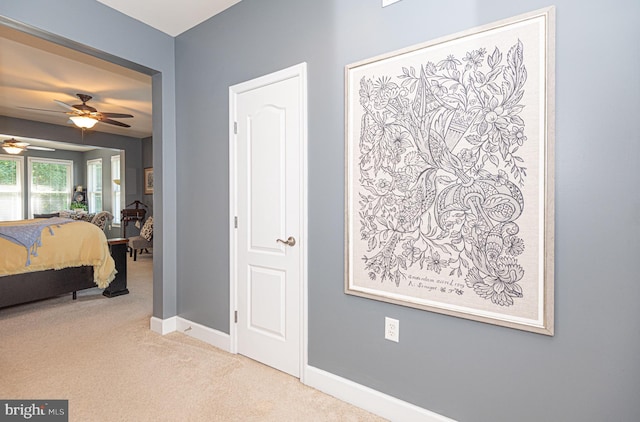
[304,366,455,422]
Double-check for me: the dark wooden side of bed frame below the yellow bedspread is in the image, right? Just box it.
[0,266,96,308]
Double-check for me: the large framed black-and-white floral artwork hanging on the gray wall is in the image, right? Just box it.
[345,8,555,335]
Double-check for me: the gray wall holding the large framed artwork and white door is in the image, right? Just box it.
[176,0,640,422]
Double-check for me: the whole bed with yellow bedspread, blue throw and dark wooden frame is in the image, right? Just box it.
[0,218,116,308]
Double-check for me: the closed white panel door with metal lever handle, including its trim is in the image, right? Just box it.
[230,65,306,377]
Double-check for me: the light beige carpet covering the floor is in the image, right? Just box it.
[0,255,383,422]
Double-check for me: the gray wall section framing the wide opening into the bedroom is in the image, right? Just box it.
[0,0,177,318]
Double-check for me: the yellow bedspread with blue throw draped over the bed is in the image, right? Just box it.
[0,219,116,288]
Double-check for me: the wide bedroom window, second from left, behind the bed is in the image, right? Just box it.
[29,157,73,216]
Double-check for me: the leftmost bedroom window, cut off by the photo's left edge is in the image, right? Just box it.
[0,155,24,221]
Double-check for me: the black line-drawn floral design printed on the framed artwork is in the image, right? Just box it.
[358,41,527,306]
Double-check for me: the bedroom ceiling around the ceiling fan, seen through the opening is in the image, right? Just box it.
[0,26,152,138]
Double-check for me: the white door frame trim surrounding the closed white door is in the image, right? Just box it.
[229,63,308,383]
